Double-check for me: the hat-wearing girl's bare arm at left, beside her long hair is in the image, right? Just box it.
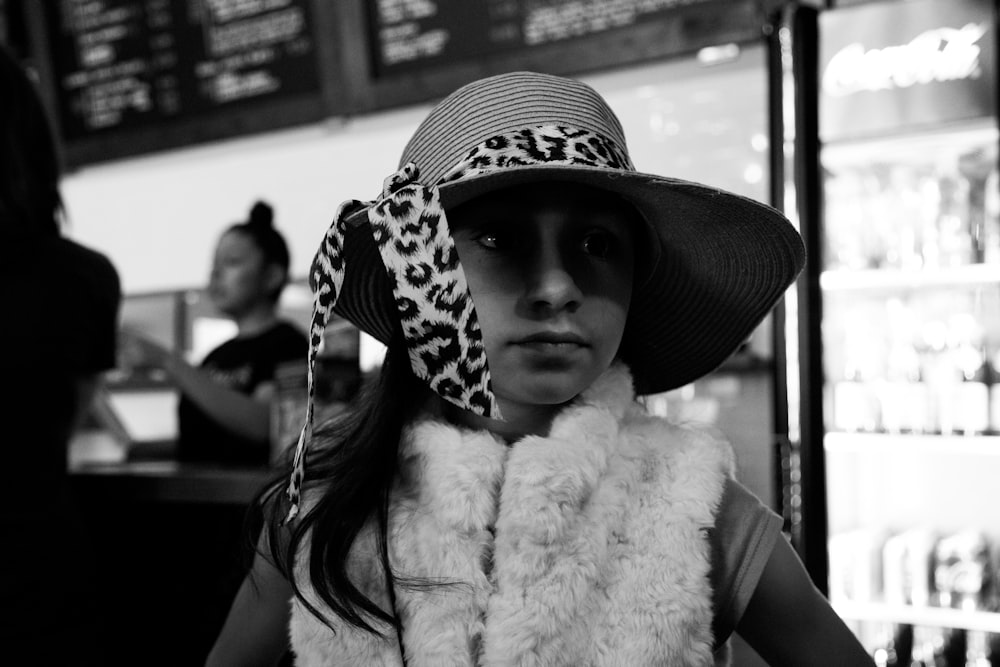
[205,538,292,667]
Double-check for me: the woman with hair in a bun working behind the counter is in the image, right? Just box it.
[123,202,309,465]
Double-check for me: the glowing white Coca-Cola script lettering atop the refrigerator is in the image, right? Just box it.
[823,23,989,97]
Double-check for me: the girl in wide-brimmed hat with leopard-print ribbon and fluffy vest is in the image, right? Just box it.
[209,72,871,667]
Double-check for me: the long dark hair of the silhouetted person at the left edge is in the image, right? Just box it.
[0,46,62,238]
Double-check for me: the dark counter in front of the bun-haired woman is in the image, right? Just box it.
[69,441,275,667]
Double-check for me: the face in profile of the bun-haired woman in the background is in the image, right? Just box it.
[208,230,268,317]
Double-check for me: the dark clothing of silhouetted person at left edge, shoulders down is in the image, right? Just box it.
[0,234,121,665]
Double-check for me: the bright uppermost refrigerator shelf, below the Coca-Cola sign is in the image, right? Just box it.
[819,264,1000,293]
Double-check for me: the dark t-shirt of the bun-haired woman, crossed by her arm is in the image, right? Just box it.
[177,322,309,465]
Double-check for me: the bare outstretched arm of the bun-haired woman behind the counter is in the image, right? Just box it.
[121,330,273,442]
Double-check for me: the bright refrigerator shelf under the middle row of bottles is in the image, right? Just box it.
[823,431,1000,458]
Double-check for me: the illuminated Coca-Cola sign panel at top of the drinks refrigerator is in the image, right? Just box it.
[820,0,996,140]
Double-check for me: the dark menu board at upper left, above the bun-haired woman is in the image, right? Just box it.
[45,0,319,141]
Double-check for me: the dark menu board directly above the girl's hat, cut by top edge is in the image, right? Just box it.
[369,0,712,76]
